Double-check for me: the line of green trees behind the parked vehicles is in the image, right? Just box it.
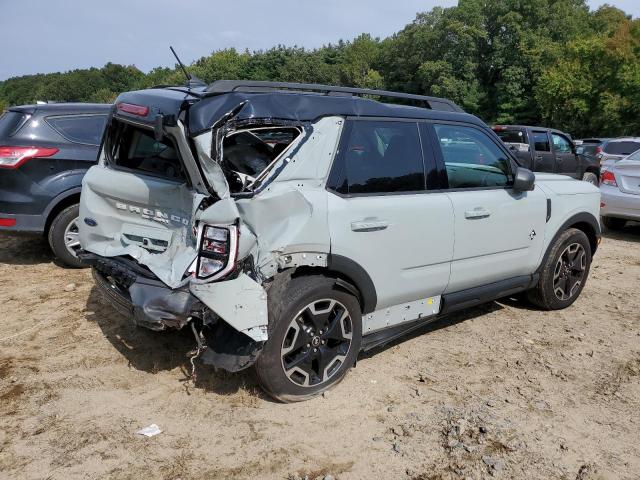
[0,0,640,137]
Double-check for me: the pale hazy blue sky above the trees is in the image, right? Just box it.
[0,0,640,80]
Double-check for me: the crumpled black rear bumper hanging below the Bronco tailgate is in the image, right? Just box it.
[78,252,202,331]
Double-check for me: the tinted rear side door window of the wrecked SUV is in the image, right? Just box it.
[330,120,425,194]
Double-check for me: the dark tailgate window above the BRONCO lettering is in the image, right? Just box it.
[106,121,186,182]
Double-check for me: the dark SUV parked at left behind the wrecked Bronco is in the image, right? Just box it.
[0,103,111,268]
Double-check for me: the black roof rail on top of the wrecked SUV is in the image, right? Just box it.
[205,80,464,112]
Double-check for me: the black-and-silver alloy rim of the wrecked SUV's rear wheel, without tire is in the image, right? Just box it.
[280,299,353,387]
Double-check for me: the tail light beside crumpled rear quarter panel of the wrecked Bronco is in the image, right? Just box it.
[196,225,239,280]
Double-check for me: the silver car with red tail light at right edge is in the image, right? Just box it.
[600,150,640,230]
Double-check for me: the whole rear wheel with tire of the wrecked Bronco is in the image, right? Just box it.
[255,275,362,402]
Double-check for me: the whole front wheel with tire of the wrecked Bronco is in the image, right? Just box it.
[527,228,591,310]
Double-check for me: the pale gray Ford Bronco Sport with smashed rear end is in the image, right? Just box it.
[79,81,600,401]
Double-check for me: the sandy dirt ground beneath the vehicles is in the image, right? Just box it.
[0,224,640,480]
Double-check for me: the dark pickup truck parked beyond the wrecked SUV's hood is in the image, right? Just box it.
[493,125,600,185]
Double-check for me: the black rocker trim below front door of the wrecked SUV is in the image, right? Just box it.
[440,273,538,314]
